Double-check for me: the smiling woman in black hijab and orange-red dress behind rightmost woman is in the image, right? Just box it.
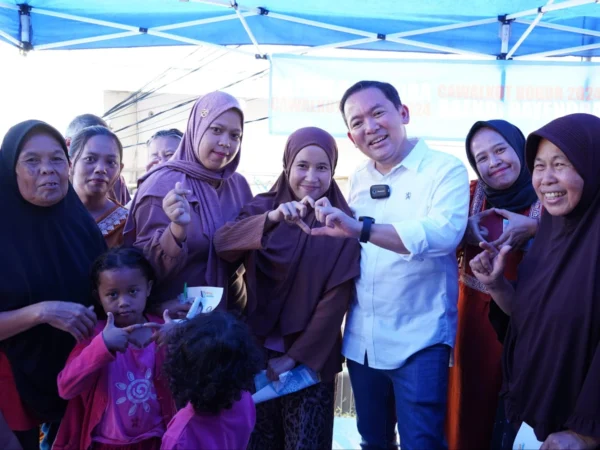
[446,120,541,449]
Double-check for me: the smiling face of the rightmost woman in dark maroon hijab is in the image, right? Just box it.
[532,139,583,216]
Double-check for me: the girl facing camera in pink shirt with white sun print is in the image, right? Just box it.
[53,248,175,450]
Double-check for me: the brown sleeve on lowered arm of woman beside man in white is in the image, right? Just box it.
[287,279,354,381]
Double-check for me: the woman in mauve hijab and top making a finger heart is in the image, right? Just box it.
[124,92,252,315]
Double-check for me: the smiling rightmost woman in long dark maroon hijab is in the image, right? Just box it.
[471,114,600,449]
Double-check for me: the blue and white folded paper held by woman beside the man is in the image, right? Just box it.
[252,364,319,403]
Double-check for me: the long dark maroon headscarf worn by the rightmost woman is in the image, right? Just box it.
[503,114,600,440]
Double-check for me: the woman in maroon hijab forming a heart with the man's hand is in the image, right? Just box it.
[215,128,360,450]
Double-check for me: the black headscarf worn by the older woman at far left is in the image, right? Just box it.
[0,120,106,420]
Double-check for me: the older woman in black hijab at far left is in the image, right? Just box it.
[0,120,106,450]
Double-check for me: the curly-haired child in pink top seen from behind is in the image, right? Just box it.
[161,311,262,450]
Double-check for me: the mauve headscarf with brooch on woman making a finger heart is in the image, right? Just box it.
[124,91,244,287]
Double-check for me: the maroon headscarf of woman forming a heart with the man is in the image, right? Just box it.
[232,127,360,336]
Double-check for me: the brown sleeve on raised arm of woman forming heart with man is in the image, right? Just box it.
[213,211,269,262]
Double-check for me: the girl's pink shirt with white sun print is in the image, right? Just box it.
[92,342,165,445]
